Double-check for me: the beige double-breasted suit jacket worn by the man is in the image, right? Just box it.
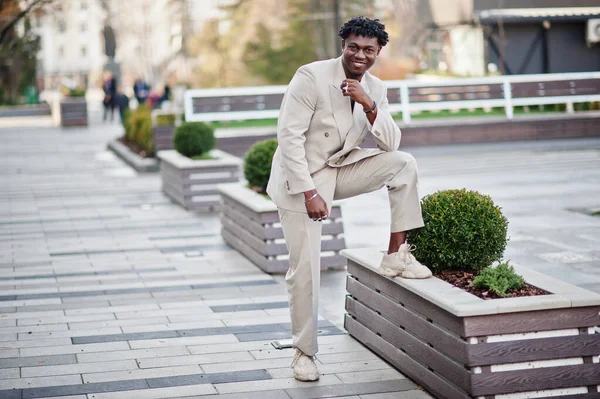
[267,57,401,213]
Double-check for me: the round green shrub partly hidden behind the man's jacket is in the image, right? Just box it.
[244,139,277,193]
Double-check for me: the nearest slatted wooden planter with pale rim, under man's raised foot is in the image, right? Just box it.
[343,249,600,399]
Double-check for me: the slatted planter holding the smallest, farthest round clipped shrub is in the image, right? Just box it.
[157,150,243,210]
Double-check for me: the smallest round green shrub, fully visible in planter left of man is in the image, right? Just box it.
[173,122,217,158]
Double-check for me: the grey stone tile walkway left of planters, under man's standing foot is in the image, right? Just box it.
[0,125,430,399]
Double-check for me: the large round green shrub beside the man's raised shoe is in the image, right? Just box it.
[407,189,508,273]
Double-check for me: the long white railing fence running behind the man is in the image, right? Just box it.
[184,72,600,124]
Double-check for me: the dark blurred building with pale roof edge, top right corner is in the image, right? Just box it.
[474,0,600,75]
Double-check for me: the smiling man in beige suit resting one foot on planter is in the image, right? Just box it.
[267,17,431,381]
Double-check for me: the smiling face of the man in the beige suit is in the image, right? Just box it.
[342,33,381,79]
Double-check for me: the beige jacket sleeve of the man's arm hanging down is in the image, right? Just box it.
[277,67,318,194]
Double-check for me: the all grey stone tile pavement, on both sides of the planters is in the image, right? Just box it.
[0,117,600,399]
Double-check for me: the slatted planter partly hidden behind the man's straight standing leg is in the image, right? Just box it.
[219,184,346,273]
